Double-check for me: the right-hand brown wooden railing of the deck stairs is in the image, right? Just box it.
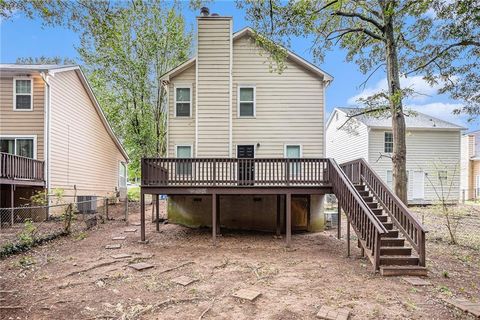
[340,158,427,267]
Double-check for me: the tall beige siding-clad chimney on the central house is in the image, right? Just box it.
[196,18,232,157]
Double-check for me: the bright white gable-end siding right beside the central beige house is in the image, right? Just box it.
[325,110,368,164]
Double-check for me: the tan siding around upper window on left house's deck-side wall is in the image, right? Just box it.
[0,75,45,160]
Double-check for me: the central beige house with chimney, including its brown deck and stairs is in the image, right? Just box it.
[140,8,432,274]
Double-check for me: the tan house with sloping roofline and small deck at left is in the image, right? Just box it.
[0,64,128,208]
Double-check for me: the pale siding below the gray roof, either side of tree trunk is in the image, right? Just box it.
[368,129,460,202]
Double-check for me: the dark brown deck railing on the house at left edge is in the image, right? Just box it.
[0,152,45,182]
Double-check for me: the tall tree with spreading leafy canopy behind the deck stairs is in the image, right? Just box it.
[242,0,479,203]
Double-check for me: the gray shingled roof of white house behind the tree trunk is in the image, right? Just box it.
[336,108,466,130]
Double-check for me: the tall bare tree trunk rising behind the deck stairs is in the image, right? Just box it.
[385,6,408,204]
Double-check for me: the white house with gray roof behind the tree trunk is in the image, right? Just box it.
[326,108,465,204]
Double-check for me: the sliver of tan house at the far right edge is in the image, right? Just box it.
[460,130,480,200]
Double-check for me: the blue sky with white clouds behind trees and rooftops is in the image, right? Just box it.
[0,1,480,130]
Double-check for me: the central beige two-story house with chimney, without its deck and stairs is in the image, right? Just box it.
[159,16,332,230]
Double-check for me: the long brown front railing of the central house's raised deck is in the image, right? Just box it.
[142,158,329,187]
